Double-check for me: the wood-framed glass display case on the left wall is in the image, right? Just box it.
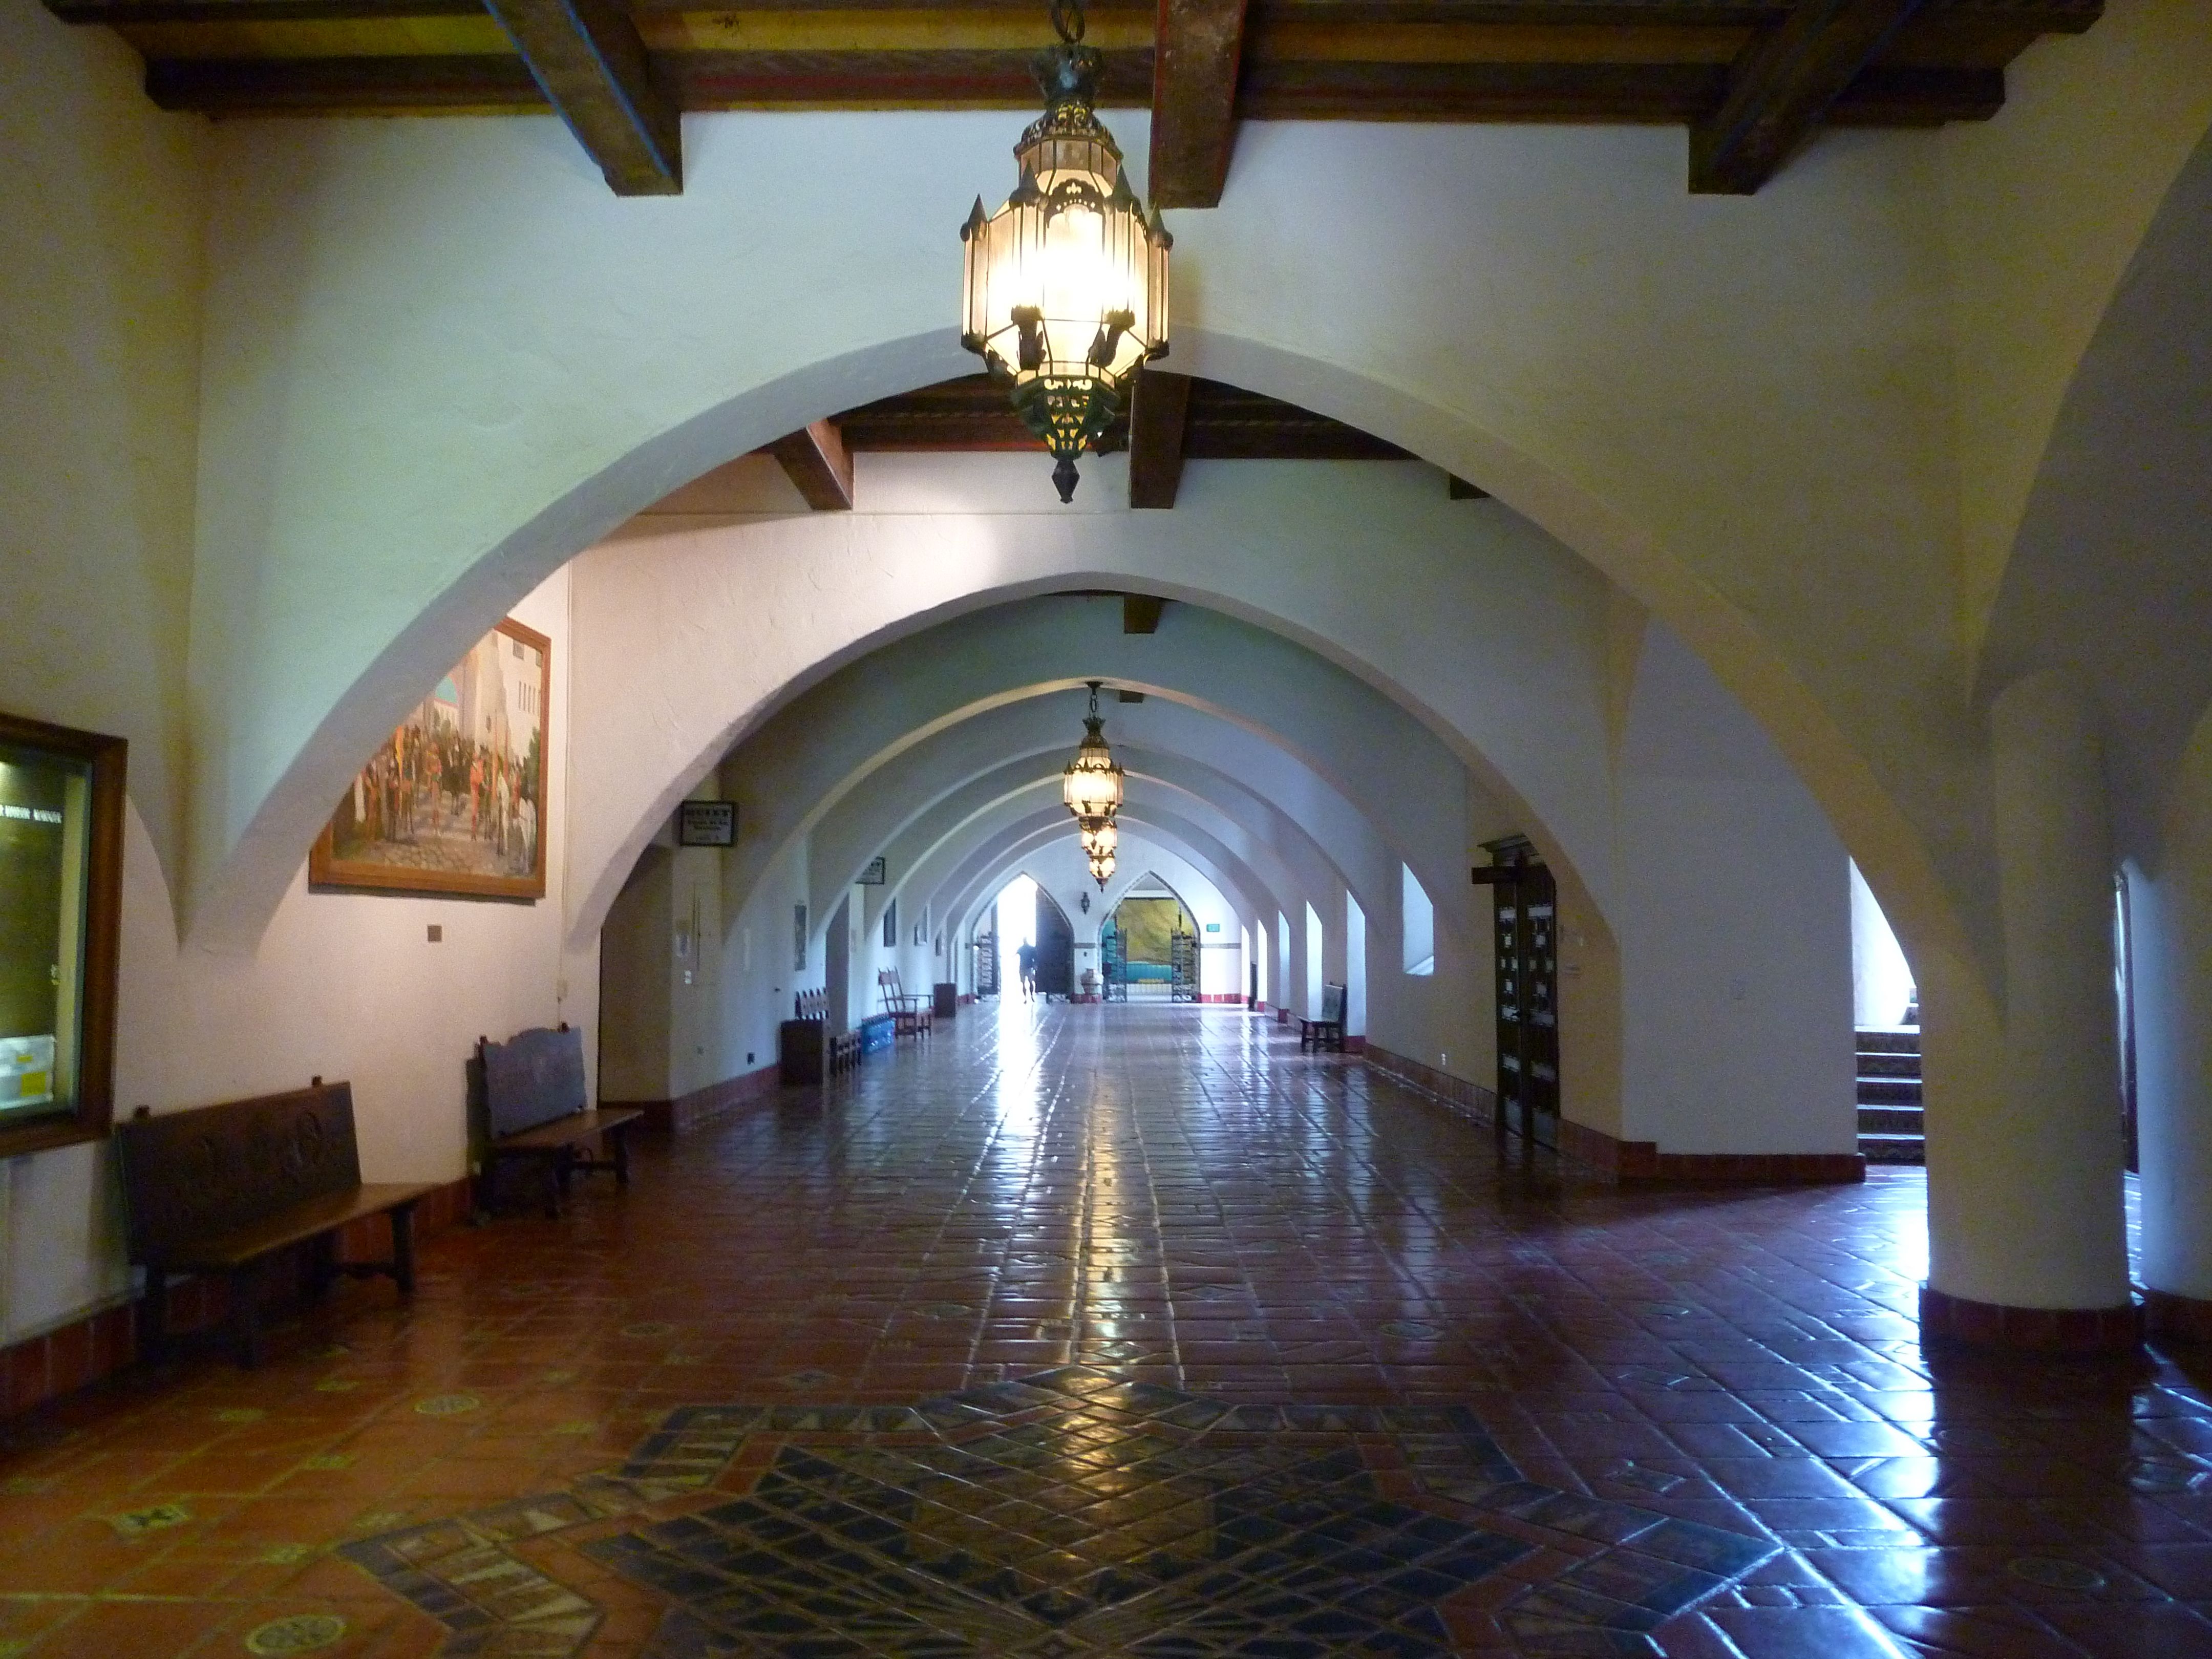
[0,714,124,1157]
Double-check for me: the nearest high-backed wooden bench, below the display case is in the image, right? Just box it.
[115,1077,436,1367]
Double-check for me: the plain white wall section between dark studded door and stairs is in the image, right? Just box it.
[1619,622,1858,1153]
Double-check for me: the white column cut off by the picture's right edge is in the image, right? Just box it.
[2128,724,2212,1341]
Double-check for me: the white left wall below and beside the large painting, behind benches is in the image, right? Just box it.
[0,575,600,1341]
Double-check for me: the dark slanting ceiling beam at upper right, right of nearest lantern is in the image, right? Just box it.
[1690,0,1920,197]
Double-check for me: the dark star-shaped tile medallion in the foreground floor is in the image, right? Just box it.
[343,1367,1776,1659]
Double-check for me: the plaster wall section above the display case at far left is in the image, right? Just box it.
[0,0,203,898]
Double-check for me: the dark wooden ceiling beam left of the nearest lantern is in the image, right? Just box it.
[484,0,684,197]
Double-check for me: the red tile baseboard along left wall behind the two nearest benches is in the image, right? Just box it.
[0,1181,473,1416]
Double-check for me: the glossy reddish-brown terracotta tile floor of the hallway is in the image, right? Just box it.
[0,1004,2212,1659]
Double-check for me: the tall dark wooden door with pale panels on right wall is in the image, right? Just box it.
[1475,836,1560,1148]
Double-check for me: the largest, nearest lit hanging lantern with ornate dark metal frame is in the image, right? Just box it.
[960,0,1175,502]
